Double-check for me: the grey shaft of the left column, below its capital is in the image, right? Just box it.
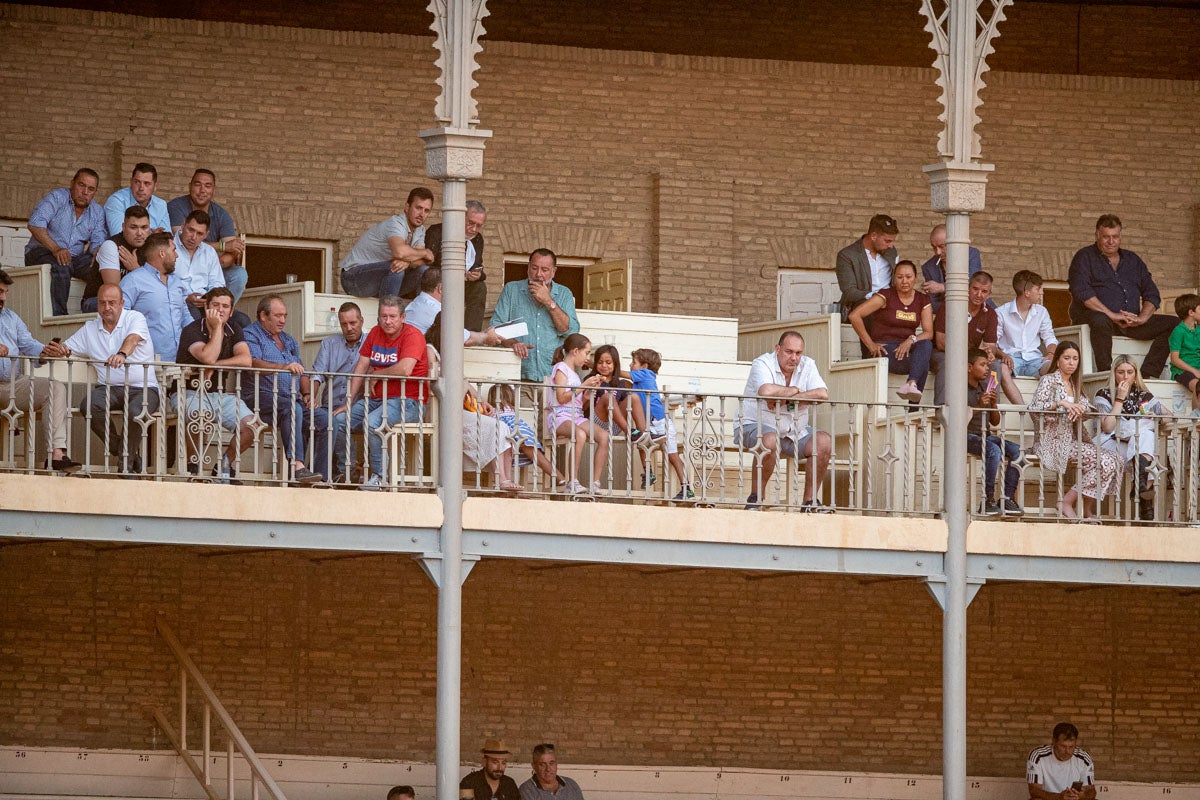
[437,176,467,800]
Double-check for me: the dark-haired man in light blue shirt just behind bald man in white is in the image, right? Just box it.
[121,231,192,361]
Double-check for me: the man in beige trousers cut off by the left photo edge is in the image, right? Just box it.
[0,270,82,473]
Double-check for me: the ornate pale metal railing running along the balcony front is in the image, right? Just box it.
[0,360,1200,525]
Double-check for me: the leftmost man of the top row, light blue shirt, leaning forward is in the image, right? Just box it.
[25,167,106,317]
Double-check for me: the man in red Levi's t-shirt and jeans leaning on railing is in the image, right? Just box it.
[332,295,430,492]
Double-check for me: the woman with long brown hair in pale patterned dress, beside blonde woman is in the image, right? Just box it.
[1030,342,1117,519]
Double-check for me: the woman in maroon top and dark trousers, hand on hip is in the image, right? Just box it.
[850,261,934,403]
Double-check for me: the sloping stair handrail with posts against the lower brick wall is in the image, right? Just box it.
[148,618,287,800]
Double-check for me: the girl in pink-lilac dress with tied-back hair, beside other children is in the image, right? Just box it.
[546,333,608,494]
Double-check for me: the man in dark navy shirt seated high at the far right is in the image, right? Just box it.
[1067,213,1177,378]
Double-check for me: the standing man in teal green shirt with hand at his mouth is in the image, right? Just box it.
[492,247,580,381]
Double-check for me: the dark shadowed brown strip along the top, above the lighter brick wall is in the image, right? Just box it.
[21,0,1200,80]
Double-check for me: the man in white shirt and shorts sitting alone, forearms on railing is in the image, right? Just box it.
[734,331,833,513]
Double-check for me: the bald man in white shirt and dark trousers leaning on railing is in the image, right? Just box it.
[47,283,162,477]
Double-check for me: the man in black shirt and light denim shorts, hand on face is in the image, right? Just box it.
[175,287,254,482]
